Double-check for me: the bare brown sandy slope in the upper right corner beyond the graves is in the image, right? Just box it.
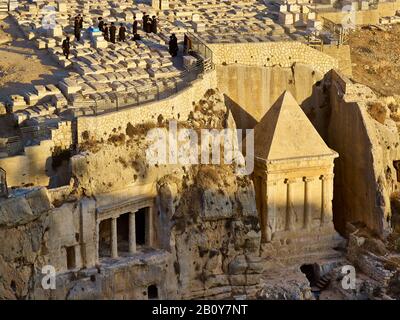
[349,25,400,96]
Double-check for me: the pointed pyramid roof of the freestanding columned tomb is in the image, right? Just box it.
[254,91,334,160]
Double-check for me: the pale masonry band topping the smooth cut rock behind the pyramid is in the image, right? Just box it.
[208,41,338,74]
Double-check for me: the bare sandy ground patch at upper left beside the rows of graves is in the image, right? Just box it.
[0,18,68,101]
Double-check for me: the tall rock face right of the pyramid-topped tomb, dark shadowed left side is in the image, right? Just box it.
[327,72,400,236]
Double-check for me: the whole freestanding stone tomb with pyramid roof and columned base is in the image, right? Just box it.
[253,91,338,264]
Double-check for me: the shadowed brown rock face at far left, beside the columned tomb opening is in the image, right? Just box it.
[0,188,51,299]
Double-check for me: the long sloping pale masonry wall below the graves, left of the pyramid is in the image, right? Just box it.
[77,71,217,143]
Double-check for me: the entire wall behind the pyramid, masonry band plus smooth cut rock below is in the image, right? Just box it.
[208,42,339,137]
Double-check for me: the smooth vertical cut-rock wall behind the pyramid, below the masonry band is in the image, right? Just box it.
[216,63,328,135]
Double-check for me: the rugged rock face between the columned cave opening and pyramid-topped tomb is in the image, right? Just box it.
[158,166,263,298]
